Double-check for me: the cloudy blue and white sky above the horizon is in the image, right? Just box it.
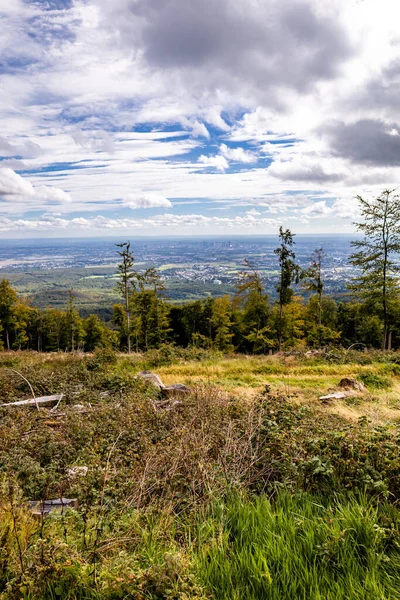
[0,0,400,238]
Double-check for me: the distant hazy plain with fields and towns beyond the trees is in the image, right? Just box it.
[0,236,352,312]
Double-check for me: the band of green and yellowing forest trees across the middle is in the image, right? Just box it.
[0,190,400,354]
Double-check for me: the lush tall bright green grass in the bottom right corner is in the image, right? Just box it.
[196,494,400,600]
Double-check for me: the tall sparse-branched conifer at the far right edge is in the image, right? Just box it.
[349,190,400,350]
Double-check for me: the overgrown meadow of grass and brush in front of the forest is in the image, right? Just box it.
[0,346,400,600]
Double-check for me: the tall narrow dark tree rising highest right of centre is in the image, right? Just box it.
[274,226,300,350]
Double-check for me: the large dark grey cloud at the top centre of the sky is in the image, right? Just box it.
[97,0,352,102]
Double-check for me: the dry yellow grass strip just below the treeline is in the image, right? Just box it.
[156,357,400,424]
